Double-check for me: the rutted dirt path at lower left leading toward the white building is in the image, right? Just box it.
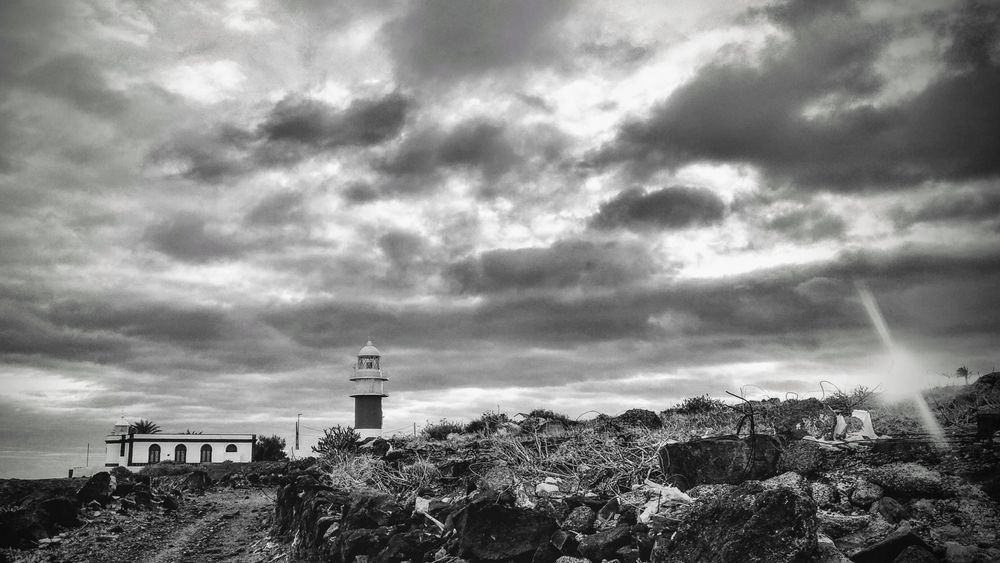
[13,489,282,563]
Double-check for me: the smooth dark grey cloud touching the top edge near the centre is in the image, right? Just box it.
[384,0,572,81]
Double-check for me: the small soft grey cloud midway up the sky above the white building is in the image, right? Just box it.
[143,213,246,264]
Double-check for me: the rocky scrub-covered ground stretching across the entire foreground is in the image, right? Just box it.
[0,376,1000,563]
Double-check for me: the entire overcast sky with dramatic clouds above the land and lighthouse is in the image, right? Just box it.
[0,0,1000,476]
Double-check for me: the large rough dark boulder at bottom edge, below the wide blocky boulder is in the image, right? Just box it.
[653,483,817,563]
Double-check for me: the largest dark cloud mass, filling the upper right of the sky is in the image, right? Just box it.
[592,2,1000,189]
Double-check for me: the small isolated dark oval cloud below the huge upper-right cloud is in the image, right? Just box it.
[590,186,726,230]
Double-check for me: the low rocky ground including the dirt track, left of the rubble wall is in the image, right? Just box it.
[0,464,287,563]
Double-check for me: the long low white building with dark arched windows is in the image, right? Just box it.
[104,419,256,469]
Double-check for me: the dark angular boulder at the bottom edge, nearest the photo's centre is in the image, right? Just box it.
[453,502,556,560]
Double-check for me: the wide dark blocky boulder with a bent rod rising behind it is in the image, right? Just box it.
[659,434,781,490]
